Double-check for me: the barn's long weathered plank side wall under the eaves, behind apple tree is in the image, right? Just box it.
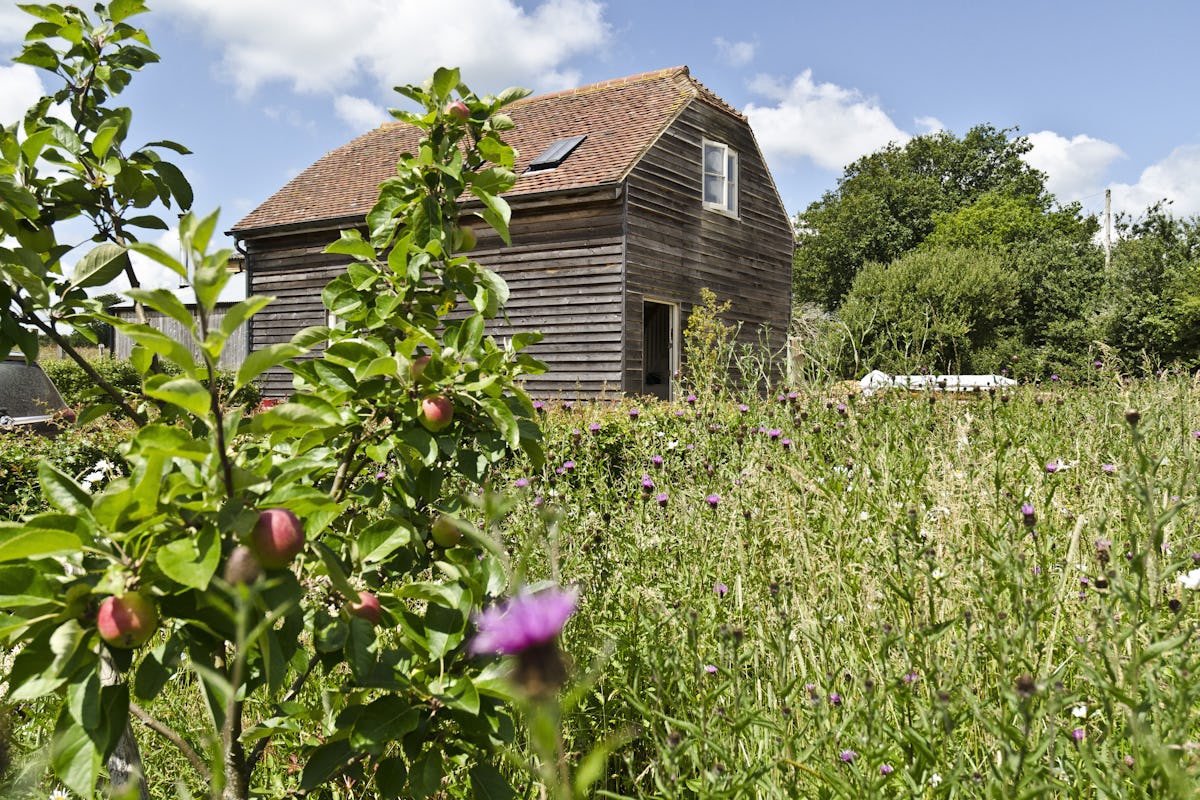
[238,192,624,398]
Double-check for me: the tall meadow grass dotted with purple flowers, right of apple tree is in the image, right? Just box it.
[508,378,1200,798]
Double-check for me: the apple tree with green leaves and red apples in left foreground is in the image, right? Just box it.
[0,0,542,799]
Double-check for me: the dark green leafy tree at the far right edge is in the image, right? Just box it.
[1102,203,1200,369]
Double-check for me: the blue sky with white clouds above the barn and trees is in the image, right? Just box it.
[0,0,1200,266]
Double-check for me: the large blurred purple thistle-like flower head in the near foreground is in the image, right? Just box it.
[469,587,580,655]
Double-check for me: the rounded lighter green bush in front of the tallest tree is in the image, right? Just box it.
[839,248,1018,374]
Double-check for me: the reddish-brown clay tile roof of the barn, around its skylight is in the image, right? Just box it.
[233,66,742,231]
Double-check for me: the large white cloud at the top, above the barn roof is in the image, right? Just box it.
[156,0,608,96]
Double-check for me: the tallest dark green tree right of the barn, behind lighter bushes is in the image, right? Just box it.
[793,125,1078,308]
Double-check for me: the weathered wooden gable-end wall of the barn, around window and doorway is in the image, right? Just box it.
[624,101,794,393]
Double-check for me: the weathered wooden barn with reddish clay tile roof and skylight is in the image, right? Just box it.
[229,67,794,398]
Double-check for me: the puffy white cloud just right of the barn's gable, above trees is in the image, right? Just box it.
[745,70,910,172]
